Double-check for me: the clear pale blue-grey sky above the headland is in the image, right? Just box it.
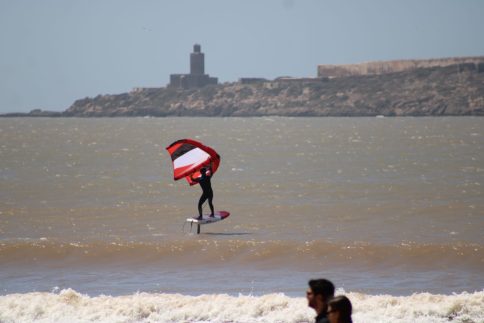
[0,0,484,113]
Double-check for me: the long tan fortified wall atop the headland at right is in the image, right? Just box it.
[318,56,484,78]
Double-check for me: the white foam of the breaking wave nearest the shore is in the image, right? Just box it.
[0,289,484,323]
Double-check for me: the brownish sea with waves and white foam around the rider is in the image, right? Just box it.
[0,117,484,323]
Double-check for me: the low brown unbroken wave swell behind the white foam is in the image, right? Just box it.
[0,238,484,271]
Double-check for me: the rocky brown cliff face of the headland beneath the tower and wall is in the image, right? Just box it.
[63,64,484,117]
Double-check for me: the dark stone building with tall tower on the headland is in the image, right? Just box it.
[168,44,218,89]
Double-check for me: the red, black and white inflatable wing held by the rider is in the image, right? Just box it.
[166,139,220,185]
